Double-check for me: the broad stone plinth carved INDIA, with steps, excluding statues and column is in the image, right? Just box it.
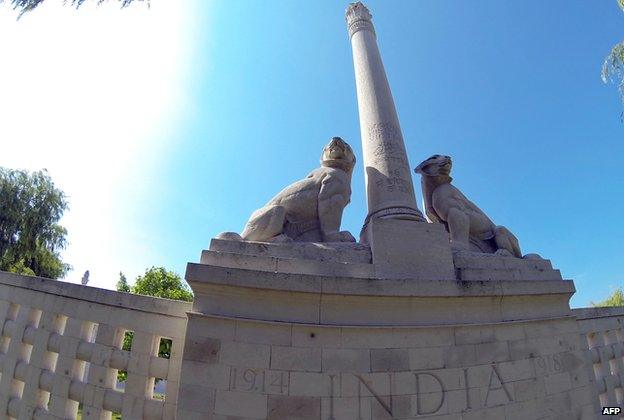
[178,241,596,420]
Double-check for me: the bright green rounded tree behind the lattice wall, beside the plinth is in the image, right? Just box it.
[117,267,193,382]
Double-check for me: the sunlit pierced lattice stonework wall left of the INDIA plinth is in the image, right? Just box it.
[0,273,190,420]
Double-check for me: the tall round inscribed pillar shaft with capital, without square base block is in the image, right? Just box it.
[346,2,425,227]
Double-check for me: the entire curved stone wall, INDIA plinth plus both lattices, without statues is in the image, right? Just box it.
[0,248,624,420]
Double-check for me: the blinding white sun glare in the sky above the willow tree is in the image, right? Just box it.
[0,0,197,287]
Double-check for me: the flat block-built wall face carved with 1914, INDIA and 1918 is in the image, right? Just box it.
[180,316,596,419]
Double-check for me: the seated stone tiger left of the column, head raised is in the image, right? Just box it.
[218,137,355,242]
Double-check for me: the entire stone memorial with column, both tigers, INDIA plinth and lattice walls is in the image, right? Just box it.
[0,2,624,420]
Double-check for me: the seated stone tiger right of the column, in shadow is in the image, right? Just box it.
[414,155,540,258]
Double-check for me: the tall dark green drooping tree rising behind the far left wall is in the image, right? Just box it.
[0,167,71,279]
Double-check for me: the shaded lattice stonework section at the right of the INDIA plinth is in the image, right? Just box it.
[574,308,624,416]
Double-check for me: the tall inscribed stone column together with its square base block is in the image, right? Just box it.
[345,2,454,279]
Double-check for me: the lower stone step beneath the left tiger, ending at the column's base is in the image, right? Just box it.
[200,250,374,278]
